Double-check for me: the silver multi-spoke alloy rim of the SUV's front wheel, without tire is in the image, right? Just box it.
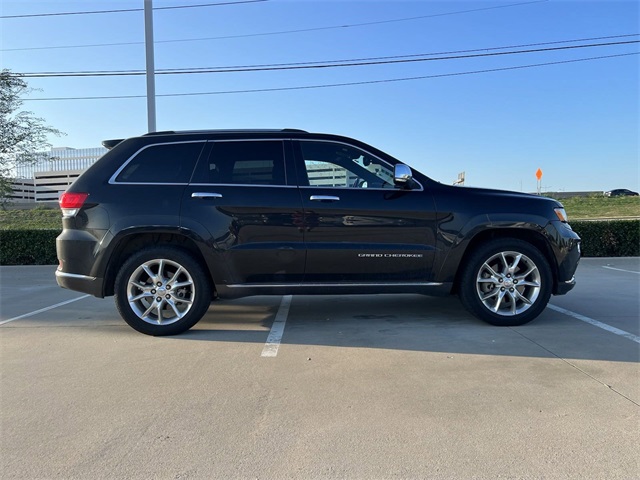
[476,251,541,317]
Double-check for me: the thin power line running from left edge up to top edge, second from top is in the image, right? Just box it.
[0,0,549,52]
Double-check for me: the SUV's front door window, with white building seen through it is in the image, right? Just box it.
[300,141,394,188]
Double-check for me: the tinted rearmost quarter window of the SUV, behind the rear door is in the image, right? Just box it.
[116,142,205,183]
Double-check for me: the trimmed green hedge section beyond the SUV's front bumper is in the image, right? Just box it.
[571,220,640,257]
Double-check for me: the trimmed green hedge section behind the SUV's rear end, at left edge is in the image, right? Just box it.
[0,229,60,265]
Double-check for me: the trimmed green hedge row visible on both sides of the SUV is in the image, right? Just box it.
[0,220,640,265]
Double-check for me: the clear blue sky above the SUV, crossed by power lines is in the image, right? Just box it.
[0,0,640,191]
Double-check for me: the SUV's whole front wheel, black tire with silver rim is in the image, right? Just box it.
[459,239,553,327]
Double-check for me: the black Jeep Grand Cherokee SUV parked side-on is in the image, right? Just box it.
[56,129,580,335]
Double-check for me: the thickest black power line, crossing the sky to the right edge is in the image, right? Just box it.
[15,40,640,78]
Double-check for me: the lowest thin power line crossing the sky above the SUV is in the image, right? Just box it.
[23,52,640,102]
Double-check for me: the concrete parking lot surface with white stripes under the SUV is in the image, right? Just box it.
[0,258,640,479]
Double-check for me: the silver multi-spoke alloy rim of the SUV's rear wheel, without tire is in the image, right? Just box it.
[127,258,196,325]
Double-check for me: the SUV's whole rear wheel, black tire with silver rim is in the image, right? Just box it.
[115,246,212,336]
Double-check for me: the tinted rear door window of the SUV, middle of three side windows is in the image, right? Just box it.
[193,140,286,185]
